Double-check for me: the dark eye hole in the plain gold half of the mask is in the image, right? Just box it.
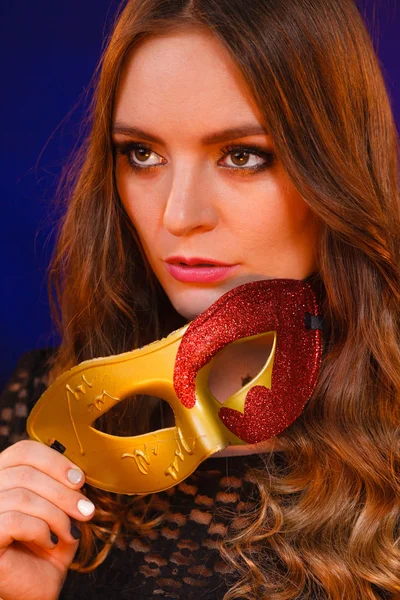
[92,394,175,437]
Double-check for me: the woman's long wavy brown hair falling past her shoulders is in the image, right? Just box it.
[49,0,400,600]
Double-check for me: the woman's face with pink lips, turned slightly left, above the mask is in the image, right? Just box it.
[113,30,317,319]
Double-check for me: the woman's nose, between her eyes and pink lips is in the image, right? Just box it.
[163,164,218,236]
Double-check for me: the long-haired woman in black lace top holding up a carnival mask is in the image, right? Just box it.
[0,0,400,600]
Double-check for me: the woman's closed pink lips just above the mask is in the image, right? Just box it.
[165,256,238,283]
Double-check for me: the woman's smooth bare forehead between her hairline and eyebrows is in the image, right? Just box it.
[114,30,261,141]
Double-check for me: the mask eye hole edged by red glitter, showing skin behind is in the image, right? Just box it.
[208,332,275,404]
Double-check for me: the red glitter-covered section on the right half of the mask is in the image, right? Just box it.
[174,279,322,444]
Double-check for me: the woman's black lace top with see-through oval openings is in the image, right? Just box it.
[0,349,390,600]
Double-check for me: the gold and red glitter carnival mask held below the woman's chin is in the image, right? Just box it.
[27,279,322,494]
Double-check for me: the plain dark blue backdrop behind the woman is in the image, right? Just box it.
[0,0,400,389]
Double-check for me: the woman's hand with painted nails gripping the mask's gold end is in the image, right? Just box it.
[0,440,94,600]
